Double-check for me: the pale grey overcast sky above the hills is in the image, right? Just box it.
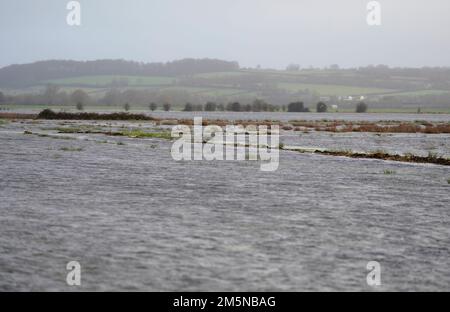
[0,0,450,68]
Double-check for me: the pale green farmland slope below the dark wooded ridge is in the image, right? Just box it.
[1,69,450,113]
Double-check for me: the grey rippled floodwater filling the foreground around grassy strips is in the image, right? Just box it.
[0,118,450,291]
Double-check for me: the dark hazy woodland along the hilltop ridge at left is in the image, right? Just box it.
[0,59,239,87]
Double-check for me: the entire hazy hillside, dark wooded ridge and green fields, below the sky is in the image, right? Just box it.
[0,59,450,108]
